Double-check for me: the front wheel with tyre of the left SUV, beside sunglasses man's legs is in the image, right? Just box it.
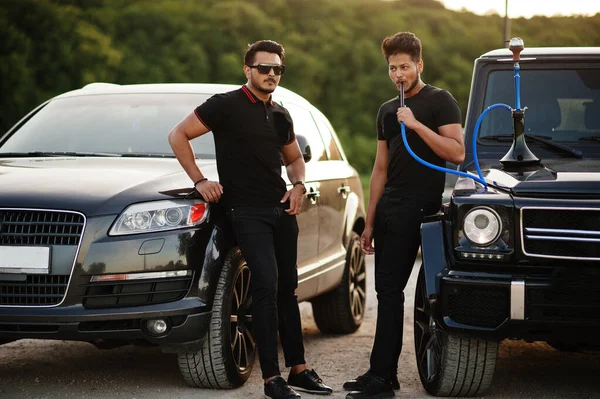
[179,248,256,388]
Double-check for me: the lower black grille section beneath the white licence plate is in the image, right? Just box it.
[0,274,69,306]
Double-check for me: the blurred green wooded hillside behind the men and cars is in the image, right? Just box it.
[0,0,600,177]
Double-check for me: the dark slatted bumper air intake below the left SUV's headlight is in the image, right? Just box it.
[83,275,193,309]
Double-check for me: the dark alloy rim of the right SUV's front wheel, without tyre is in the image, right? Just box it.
[414,275,444,382]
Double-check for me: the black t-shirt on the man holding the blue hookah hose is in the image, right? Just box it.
[377,85,462,201]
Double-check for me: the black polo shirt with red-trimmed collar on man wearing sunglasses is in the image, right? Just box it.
[195,86,296,207]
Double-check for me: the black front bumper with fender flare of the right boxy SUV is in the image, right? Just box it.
[422,222,600,343]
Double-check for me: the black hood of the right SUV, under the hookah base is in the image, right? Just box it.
[484,159,600,198]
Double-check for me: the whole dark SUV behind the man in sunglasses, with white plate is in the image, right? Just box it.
[0,83,366,388]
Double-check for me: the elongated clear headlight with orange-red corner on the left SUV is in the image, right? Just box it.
[108,200,208,236]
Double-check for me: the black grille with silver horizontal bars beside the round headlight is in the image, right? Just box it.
[521,208,600,261]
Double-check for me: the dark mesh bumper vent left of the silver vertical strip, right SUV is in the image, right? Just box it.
[442,284,509,328]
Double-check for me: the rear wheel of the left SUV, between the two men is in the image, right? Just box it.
[312,232,367,334]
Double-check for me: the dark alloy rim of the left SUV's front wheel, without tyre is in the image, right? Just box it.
[229,263,256,373]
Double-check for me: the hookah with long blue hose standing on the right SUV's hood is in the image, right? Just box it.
[399,37,540,187]
